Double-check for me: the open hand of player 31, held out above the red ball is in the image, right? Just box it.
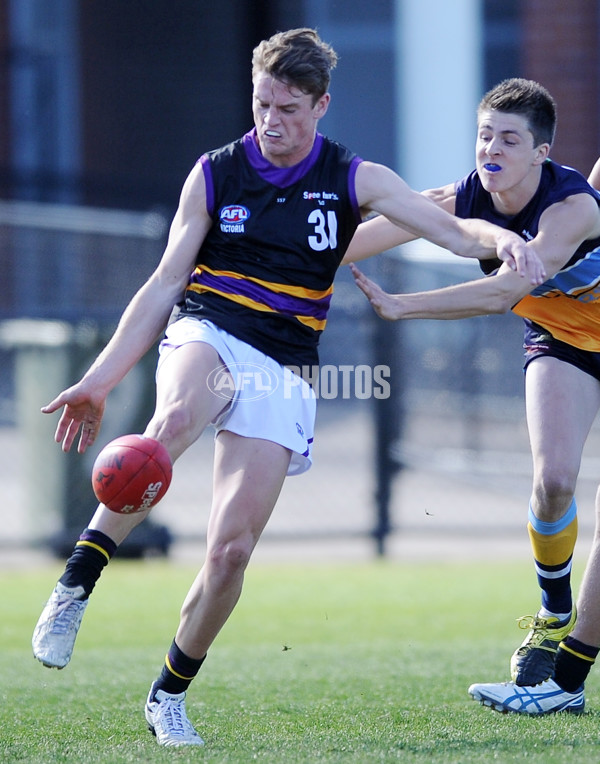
[42,383,106,454]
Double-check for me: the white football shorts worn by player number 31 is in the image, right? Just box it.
[157,316,317,475]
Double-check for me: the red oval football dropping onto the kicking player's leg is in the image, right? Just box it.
[92,435,173,514]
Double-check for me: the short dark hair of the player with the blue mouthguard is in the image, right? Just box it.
[477,77,556,146]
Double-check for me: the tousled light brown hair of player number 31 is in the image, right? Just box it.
[252,27,337,103]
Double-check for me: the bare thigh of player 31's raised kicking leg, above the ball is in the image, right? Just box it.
[145,342,229,461]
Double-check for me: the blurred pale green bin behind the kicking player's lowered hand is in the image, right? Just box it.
[0,318,172,557]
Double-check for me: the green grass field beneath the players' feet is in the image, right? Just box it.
[0,561,600,764]
